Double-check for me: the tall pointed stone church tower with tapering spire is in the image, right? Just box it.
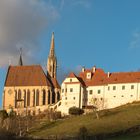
[47,32,57,78]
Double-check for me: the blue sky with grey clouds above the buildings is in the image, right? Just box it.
[0,0,140,107]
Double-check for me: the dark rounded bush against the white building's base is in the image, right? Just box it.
[69,106,84,115]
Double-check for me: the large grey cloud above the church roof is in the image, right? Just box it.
[0,0,59,66]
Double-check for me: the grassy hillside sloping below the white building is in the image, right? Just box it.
[30,102,140,140]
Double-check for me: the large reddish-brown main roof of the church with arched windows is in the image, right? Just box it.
[5,65,51,86]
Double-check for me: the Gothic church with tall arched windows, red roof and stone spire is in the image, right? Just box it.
[3,33,61,115]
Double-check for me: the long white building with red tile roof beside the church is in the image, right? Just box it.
[57,67,140,114]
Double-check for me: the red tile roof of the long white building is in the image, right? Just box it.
[66,68,140,86]
